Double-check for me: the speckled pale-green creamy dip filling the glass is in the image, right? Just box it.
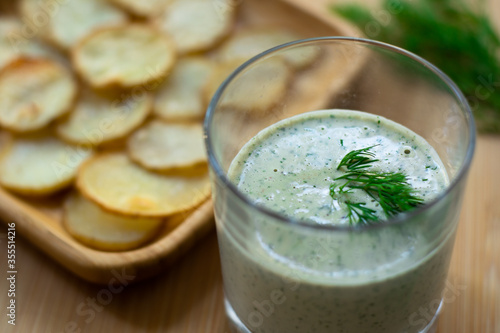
[223,110,452,333]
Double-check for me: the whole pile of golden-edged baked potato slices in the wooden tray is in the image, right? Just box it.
[0,0,313,251]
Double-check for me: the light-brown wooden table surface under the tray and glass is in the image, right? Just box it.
[0,0,500,333]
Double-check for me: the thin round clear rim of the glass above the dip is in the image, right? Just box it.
[203,36,476,232]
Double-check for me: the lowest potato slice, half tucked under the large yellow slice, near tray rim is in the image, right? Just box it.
[64,193,163,251]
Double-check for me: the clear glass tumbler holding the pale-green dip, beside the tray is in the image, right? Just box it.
[205,37,475,333]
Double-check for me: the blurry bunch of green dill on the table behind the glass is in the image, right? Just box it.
[333,0,500,133]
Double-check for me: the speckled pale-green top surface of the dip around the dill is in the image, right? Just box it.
[230,110,447,224]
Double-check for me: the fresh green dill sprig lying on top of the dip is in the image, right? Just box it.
[330,146,424,225]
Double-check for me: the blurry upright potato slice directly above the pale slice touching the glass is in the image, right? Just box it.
[154,57,214,121]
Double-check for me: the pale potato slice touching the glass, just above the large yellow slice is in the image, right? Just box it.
[128,121,207,172]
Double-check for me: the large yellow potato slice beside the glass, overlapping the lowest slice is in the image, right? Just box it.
[76,153,210,217]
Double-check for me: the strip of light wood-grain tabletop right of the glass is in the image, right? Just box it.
[439,136,500,333]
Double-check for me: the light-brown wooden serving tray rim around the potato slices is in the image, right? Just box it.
[0,0,359,284]
